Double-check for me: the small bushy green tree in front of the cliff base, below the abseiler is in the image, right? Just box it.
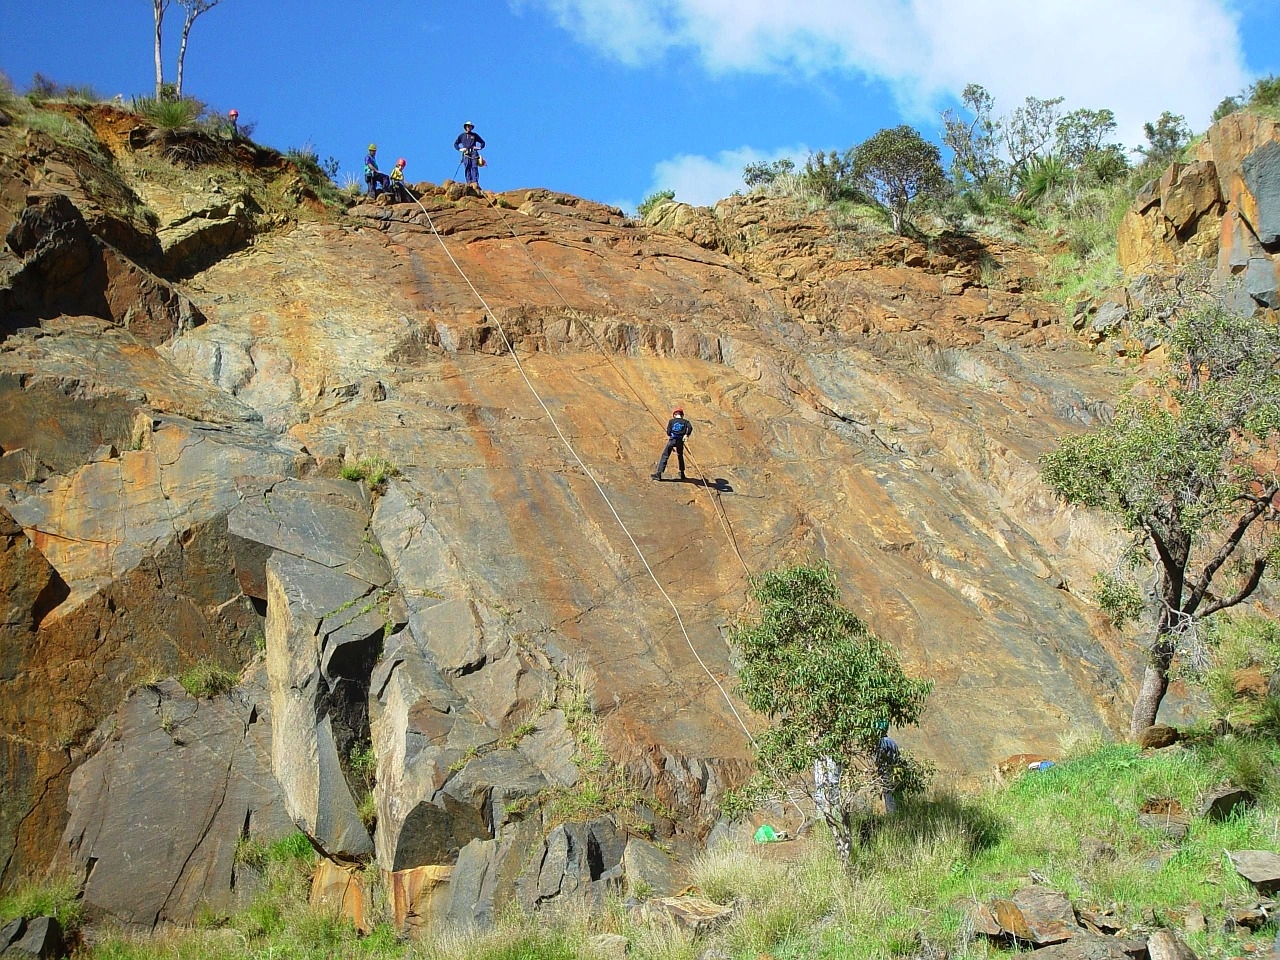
[730,563,932,859]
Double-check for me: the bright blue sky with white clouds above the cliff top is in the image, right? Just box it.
[0,0,1280,212]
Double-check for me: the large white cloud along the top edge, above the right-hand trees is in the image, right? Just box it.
[535,0,1248,143]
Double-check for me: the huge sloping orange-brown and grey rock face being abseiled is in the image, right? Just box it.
[0,109,1133,925]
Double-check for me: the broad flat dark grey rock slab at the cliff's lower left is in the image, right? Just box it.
[54,676,294,929]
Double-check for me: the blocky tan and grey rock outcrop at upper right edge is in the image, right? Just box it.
[1117,111,1280,310]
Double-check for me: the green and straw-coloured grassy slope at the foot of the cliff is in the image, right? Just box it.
[0,736,1280,960]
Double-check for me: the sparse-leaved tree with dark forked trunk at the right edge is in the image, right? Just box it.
[1041,289,1280,737]
